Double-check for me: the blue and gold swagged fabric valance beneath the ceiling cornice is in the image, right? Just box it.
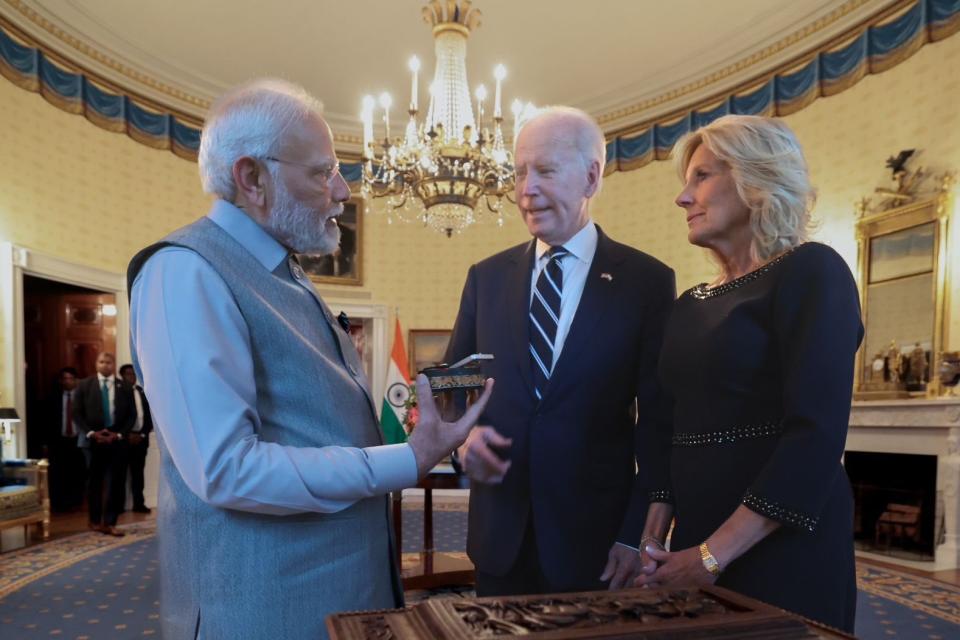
[0,0,960,182]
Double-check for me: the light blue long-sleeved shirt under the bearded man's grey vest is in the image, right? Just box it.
[130,201,417,515]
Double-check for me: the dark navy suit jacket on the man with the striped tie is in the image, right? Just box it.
[446,227,676,590]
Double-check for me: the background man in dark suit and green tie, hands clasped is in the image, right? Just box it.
[73,353,136,536]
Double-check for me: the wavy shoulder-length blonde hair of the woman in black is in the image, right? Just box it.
[674,116,816,263]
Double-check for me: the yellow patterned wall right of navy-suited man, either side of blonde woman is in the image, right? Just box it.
[595,30,960,349]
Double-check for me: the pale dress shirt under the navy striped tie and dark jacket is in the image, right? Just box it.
[530,220,597,373]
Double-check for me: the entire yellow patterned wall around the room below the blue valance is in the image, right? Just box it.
[0,31,960,404]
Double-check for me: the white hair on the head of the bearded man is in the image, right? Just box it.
[197,78,323,202]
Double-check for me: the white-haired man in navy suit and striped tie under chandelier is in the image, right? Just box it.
[446,107,675,595]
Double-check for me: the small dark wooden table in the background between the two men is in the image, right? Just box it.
[393,473,474,589]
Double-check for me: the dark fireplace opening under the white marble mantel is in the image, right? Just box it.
[844,451,937,561]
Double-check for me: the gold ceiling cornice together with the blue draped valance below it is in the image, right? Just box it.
[0,0,960,171]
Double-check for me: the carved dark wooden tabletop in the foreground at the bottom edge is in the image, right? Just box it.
[327,586,853,640]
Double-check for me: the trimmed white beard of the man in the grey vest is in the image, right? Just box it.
[264,175,343,255]
